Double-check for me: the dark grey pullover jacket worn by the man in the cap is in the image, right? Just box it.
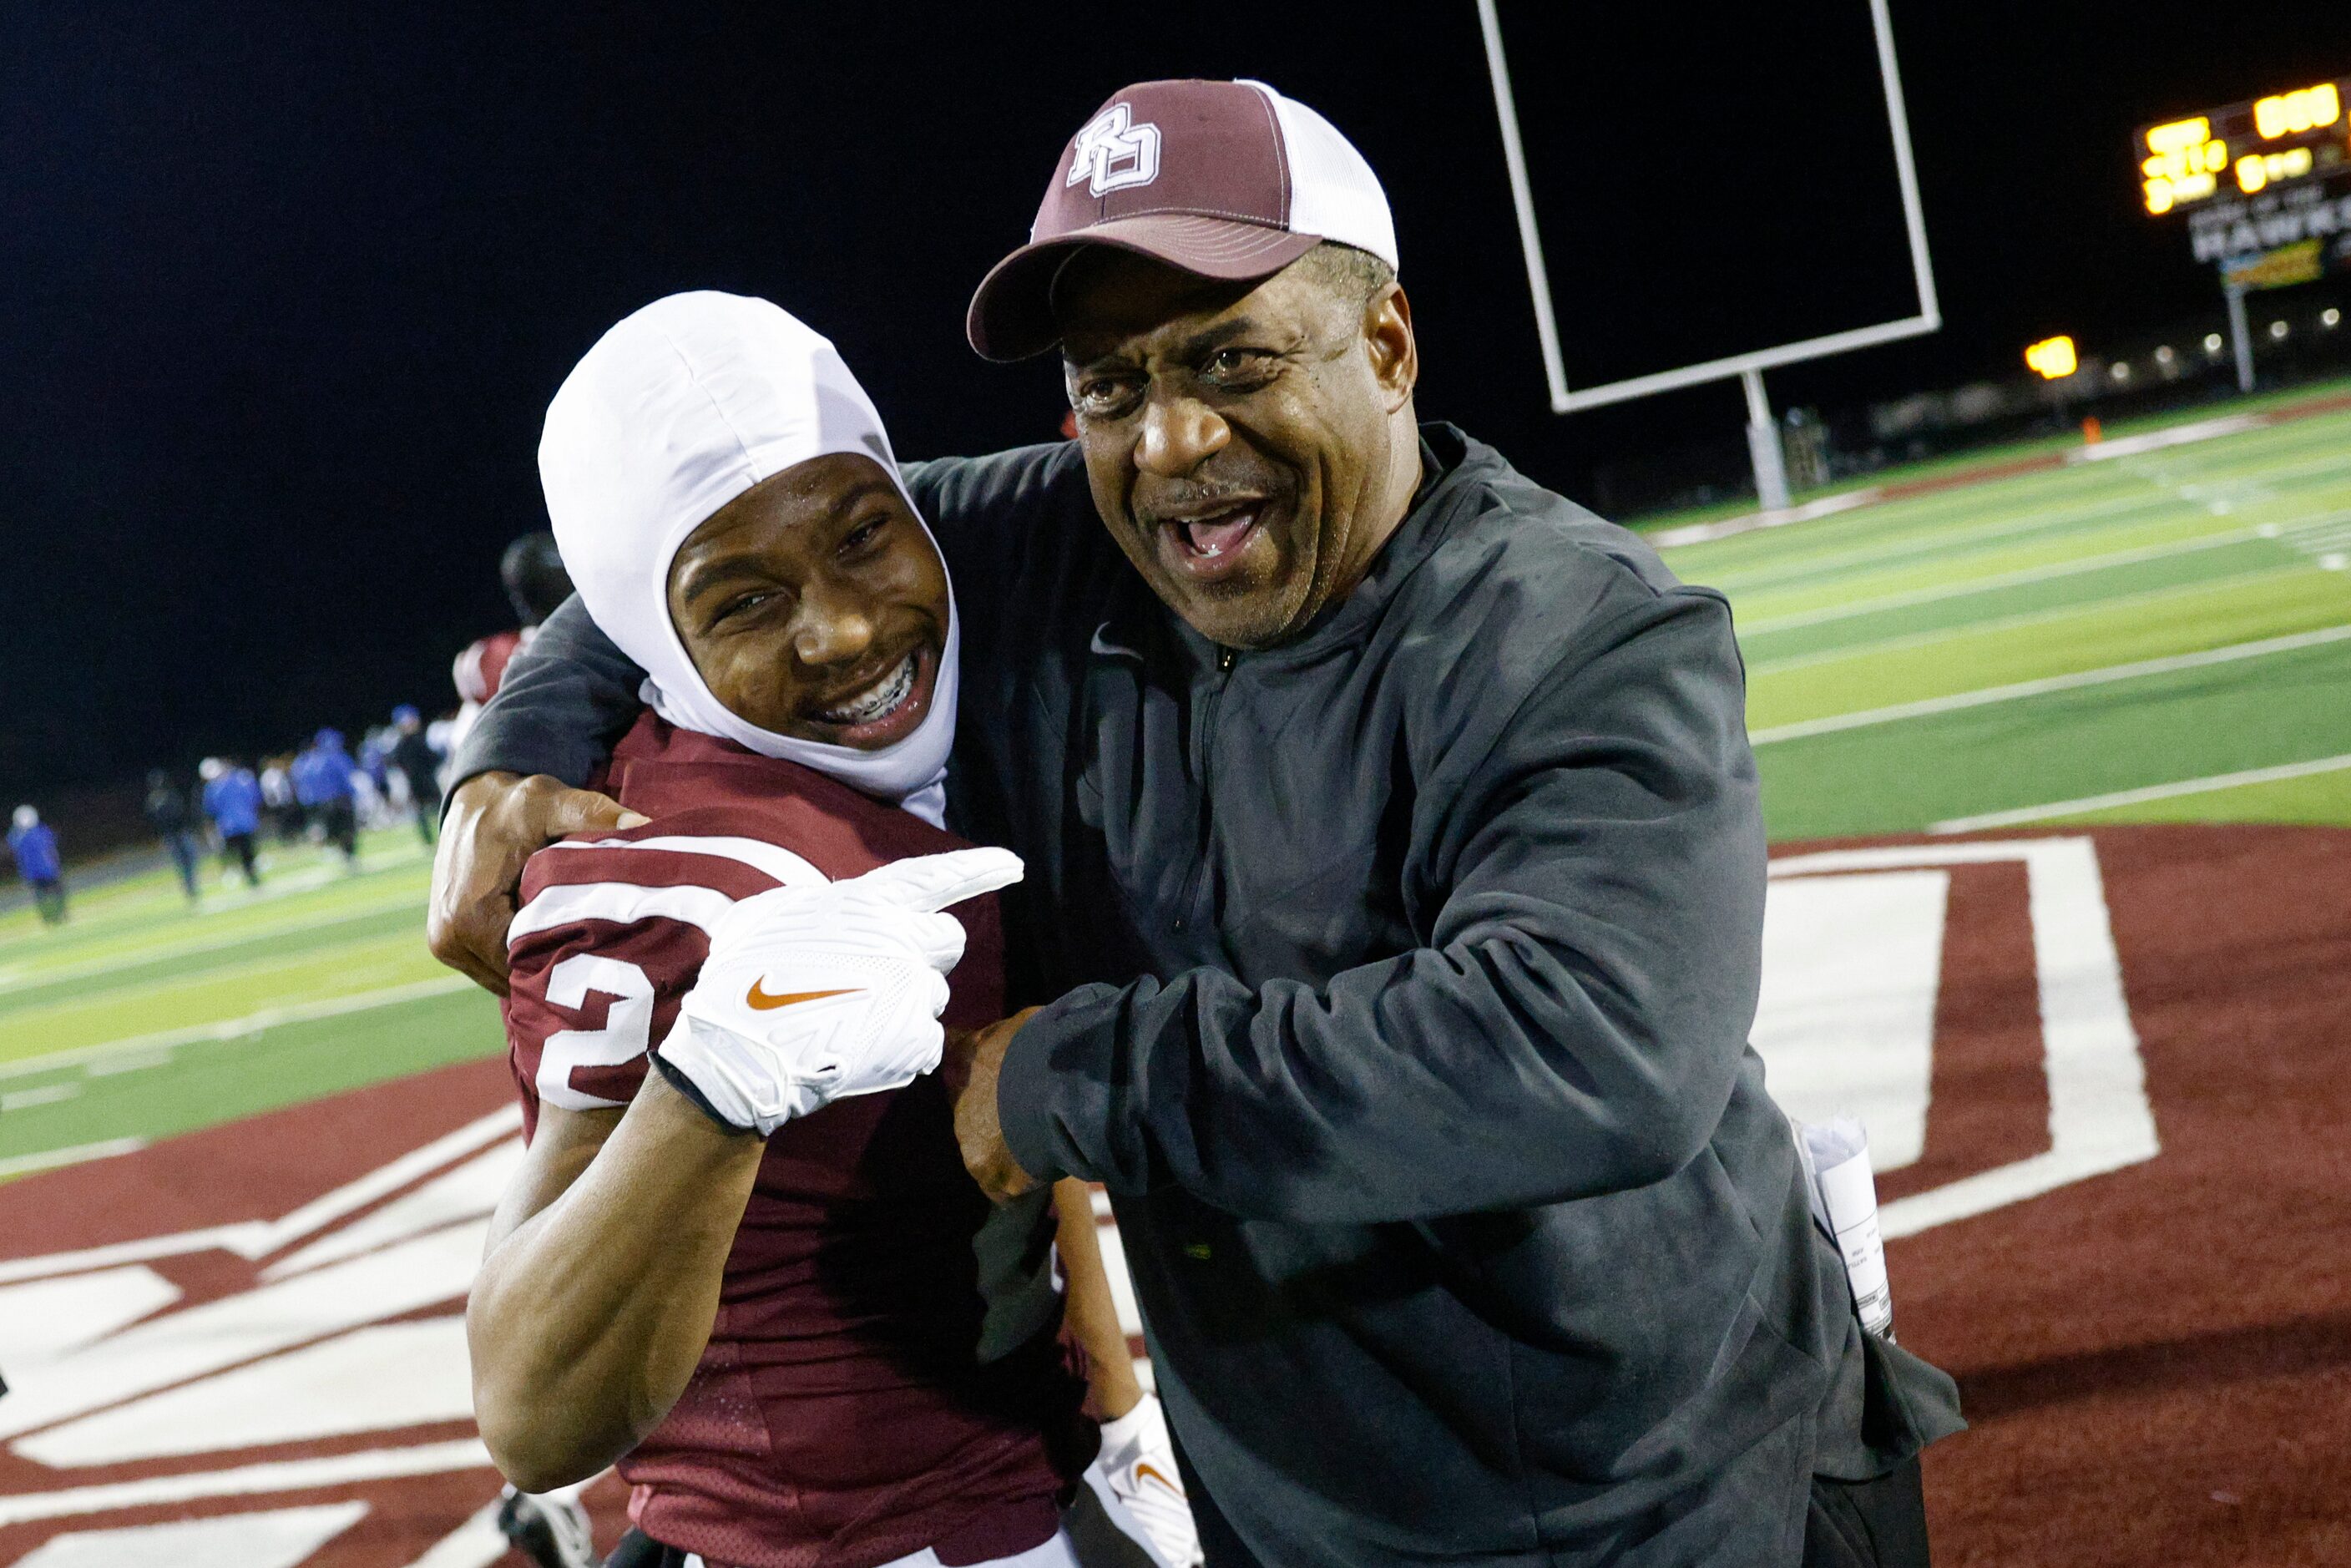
[458,426,1959,1568]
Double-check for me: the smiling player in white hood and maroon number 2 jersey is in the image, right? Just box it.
[468,294,1196,1568]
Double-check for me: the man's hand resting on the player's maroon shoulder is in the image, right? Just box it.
[426,773,651,997]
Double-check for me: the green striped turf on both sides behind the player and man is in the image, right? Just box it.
[13,390,2351,1178]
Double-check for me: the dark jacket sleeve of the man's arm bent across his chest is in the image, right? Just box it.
[997,590,1766,1225]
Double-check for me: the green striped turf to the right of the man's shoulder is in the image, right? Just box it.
[1665,399,2351,842]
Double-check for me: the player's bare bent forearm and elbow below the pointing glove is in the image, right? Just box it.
[466,1072,766,1493]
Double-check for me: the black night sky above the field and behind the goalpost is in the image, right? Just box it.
[0,0,2351,804]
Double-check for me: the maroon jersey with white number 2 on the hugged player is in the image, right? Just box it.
[505,712,1093,1568]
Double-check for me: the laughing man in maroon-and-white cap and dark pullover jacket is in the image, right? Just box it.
[432,83,1959,1568]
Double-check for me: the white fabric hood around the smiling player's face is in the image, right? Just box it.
[538,291,962,825]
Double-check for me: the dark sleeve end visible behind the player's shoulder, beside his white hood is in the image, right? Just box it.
[449,597,645,795]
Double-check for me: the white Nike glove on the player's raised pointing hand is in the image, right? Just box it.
[660,848,1020,1138]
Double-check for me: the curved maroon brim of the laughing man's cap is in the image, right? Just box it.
[964,211,1322,362]
